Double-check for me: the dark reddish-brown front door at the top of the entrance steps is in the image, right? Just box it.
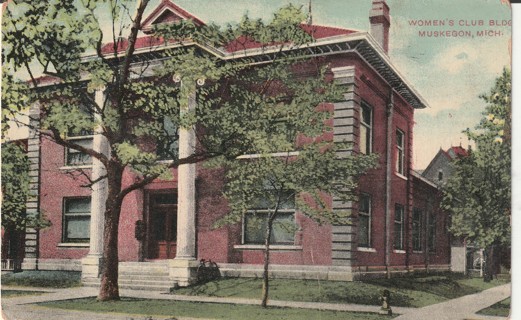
[147,193,177,259]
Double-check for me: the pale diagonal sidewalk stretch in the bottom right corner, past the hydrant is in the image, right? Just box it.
[395,284,511,320]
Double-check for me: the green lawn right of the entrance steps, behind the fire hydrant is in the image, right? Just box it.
[172,275,508,307]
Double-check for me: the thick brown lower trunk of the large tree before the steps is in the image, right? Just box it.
[98,165,123,301]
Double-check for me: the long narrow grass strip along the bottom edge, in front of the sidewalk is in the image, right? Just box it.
[39,298,391,320]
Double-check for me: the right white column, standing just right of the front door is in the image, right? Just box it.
[170,85,197,286]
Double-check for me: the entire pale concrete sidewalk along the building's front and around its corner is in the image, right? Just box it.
[2,284,510,320]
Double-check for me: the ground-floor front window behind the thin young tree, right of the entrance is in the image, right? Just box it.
[243,190,296,245]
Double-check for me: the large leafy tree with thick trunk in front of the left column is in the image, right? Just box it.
[2,0,370,300]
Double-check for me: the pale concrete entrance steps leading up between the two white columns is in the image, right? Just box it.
[82,261,177,292]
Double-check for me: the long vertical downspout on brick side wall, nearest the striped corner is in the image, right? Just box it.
[385,89,394,278]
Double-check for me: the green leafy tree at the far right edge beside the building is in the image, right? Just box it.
[442,68,512,280]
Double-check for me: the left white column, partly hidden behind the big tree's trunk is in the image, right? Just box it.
[82,90,110,278]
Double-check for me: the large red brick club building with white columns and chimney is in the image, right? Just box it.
[24,0,450,289]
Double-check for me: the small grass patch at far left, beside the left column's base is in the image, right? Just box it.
[2,271,81,288]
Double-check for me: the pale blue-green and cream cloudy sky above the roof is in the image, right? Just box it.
[4,0,511,170]
